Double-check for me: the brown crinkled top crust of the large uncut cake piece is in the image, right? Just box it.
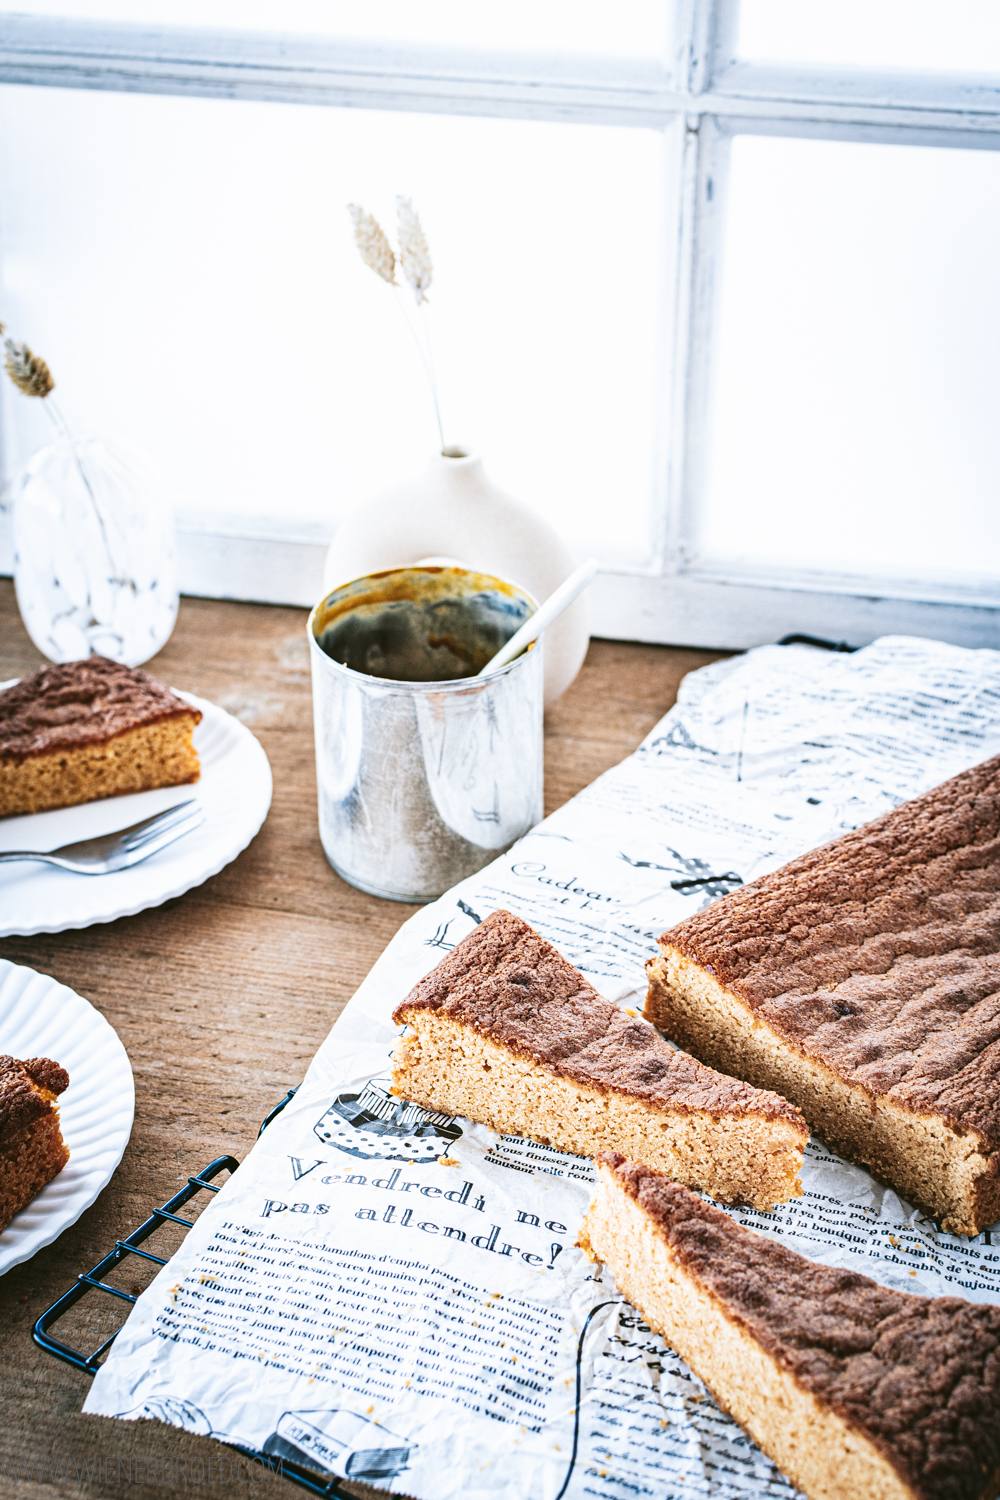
[660,756,1000,1151]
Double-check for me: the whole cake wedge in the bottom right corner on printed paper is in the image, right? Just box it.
[580,1154,1000,1500]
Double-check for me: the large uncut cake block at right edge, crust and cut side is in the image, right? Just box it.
[645,758,1000,1235]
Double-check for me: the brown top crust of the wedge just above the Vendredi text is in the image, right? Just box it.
[393,911,805,1131]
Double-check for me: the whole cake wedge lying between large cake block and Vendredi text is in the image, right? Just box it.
[393,911,808,1209]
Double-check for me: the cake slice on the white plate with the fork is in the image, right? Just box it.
[0,657,201,818]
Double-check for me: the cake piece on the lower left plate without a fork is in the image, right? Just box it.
[0,1058,69,1232]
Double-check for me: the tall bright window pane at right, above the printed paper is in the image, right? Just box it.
[700,137,1000,581]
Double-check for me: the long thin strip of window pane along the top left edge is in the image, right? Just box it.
[0,0,672,57]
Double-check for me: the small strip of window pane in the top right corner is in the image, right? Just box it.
[739,0,1000,72]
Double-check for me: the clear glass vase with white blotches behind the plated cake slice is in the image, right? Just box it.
[12,434,177,666]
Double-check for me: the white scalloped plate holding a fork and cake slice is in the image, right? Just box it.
[0,683,271,936]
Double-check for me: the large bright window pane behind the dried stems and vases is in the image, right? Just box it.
[0,87,663,561]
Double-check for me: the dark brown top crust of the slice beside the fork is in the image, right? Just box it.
[0,657,201,762]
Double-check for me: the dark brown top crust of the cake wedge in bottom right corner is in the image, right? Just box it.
[597,1152,1000,1500]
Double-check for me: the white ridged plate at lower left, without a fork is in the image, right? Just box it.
[0,959,135,1275]
